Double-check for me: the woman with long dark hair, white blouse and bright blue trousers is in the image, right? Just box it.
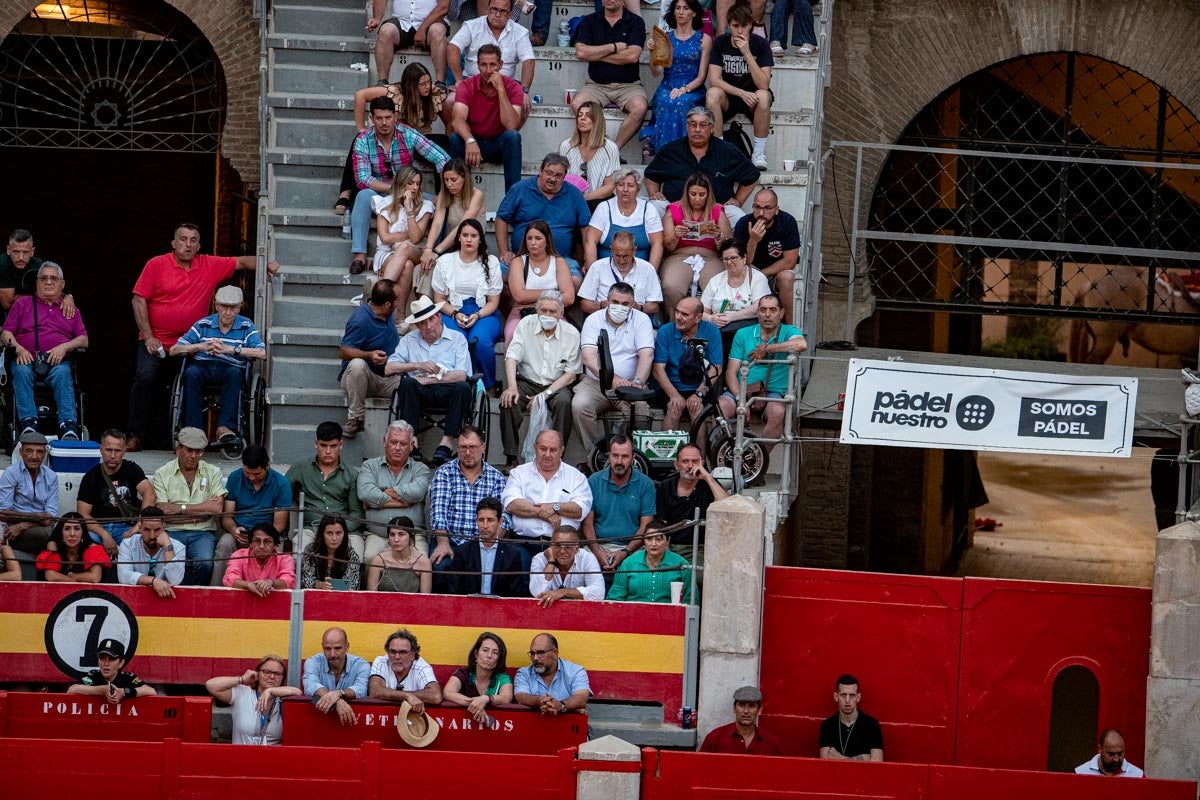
[433,218,504,390]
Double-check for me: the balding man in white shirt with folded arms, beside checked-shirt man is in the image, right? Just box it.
[500,431,592,570]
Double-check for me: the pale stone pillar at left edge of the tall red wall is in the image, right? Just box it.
[696,494,766,741]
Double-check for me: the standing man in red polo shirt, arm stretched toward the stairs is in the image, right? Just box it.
[126,222,280,452]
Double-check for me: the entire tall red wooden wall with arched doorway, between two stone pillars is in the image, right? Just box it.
[761,567,1150,769]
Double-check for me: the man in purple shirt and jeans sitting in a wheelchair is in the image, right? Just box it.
[0,261,88,439]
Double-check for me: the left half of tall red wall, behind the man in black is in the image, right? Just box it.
[761,567,962,764]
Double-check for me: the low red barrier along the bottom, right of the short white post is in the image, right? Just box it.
[642,750,1196,800]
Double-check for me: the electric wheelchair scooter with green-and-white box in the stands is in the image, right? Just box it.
[588,331,768,488]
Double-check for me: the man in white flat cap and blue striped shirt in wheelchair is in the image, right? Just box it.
[170,287,266,445]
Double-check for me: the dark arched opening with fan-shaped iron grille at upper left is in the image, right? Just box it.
[0,0,229,431]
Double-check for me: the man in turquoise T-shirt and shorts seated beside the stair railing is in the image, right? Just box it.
[719,294,809,449]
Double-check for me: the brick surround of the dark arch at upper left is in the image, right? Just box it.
[0,0,259,185]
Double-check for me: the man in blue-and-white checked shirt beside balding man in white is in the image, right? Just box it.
[430,425,512,594]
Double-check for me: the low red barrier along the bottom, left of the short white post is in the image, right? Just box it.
[0,739,575,800]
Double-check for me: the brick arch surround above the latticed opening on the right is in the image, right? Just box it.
[818,0,1200,341]
